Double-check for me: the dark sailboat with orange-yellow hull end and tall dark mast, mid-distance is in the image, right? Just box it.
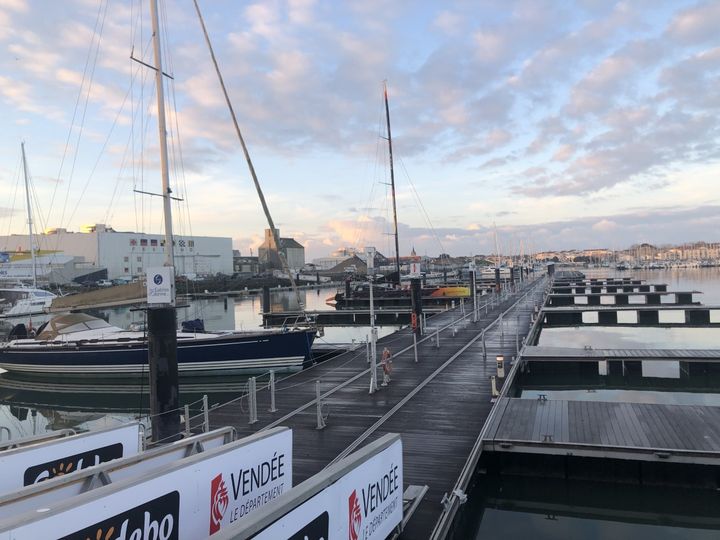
[327,82,470,309]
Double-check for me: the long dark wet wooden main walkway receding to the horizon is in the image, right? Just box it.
[210,282,542,539]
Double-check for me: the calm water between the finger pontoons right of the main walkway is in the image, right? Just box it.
[454,268,720,540]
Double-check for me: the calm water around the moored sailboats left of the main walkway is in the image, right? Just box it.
[0,287,396,438]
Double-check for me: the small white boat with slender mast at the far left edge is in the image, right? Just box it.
[0,142,57,318]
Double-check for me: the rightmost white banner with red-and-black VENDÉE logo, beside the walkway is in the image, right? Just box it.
[253,440,403,540]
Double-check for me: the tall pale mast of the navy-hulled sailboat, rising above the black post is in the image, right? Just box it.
[150,0,175,272]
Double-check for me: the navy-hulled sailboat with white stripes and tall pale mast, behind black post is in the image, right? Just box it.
[0,1,316,377]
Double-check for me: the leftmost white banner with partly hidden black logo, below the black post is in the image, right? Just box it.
[0,423,141,493]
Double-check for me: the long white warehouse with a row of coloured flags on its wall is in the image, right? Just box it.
[0,224,233,279]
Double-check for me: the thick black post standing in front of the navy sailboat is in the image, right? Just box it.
[148,307,181,442]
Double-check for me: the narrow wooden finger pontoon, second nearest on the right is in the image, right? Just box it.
[523,346,720,362]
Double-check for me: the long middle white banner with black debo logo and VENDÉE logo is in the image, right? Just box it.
[0,428,292,540]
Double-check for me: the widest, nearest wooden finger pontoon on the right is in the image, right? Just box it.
[485,397,720,465]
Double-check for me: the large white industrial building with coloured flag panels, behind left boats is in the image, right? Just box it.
[0,224,233,283]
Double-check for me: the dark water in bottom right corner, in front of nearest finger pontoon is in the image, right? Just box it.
[452,470,720,540]
